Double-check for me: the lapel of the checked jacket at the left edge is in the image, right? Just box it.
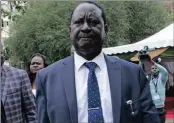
[1,65,10,105]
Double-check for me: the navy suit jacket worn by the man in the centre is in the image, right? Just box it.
[36,56,160,123]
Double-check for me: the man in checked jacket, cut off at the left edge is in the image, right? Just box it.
[0,44,37,123]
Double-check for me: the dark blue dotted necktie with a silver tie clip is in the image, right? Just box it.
[85,62,104,123]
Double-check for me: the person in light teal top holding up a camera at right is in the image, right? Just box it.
[147,56,168,123]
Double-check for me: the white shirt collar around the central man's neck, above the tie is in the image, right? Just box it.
[74,52,106,70]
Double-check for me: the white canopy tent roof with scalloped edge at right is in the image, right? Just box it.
[103,23,174,55]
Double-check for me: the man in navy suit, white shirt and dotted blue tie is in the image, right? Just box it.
[36,1,159,123]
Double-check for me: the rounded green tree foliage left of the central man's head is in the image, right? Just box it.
[6,2,77,65]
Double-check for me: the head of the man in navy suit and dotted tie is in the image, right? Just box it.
[70,3,106,60]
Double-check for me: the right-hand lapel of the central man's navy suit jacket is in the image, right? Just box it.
[105,55,121,123]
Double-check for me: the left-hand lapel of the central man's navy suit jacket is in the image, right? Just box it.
[62,56,78,123]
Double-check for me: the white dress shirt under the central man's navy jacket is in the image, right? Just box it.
[74,52,113,123]
